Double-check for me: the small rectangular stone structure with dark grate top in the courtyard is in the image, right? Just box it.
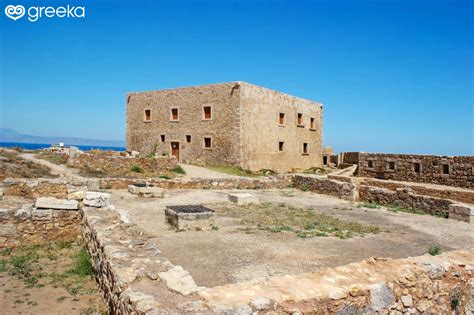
[165,205,215,231]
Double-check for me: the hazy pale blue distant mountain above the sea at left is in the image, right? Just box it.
[0,128,125,147]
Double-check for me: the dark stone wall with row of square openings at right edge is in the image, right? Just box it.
[358,153,474,188]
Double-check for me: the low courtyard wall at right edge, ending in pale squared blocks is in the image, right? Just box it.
[359,185,474,222]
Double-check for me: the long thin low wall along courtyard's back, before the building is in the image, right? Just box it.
[100,176,292,189]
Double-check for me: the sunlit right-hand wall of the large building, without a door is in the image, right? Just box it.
[240,82,323,173]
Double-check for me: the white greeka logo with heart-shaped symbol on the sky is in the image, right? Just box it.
[5,4,86,22]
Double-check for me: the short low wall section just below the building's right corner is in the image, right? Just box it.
[293,175,356,200]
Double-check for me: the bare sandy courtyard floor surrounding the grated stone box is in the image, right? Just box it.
[112,189,474,286]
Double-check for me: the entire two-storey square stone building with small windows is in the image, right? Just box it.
[126,82,322,172]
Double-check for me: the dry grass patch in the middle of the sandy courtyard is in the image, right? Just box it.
[222,203,380,238]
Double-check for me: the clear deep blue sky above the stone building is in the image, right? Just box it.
[0,0,474,155]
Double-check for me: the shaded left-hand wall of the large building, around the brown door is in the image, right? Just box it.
[126,82,241,166]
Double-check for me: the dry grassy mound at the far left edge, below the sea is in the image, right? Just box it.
[0,149,57,180]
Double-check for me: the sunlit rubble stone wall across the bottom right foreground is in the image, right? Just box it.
[199,251,474,315]
